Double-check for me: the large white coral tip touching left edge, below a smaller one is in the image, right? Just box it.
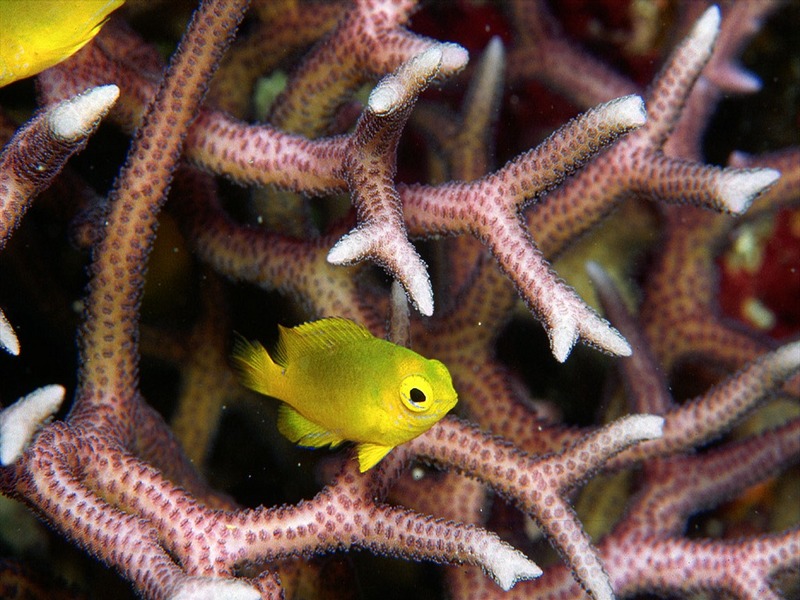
[0,385,66,465]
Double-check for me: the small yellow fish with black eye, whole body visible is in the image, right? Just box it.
[233,317,458,473]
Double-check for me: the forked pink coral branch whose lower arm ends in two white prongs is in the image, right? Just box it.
[400,97,644,361]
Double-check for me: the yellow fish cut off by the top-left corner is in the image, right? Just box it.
[0,0,124,87]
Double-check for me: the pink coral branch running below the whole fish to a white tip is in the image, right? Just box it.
[36,412,540,590]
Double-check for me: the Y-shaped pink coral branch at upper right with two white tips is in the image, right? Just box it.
[527,8,779,264]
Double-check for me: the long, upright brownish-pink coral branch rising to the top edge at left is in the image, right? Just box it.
[73,2,246,428]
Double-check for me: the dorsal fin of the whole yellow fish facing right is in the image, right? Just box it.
[274,317,374,367]
